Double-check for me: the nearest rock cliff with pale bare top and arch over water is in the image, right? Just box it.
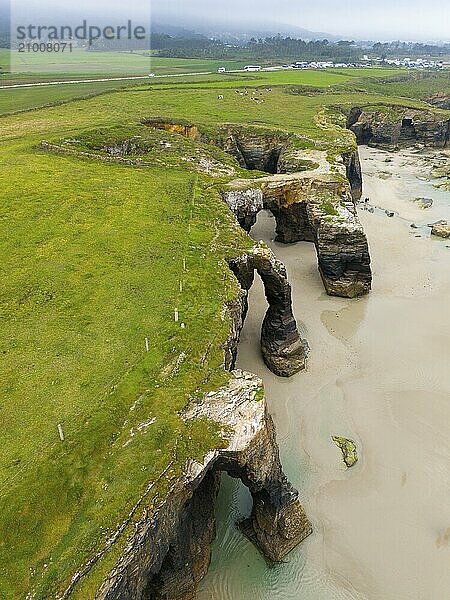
[95,371,312,600]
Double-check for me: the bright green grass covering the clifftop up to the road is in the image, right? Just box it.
[0,63,450,600]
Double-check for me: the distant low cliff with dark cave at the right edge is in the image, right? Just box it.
[347,106,450,148]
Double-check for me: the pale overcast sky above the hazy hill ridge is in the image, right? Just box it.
[6,0,450,41]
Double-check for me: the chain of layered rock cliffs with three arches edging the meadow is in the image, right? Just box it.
[34,119,371,600]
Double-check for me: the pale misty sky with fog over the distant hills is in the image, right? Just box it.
[0,0,450,42]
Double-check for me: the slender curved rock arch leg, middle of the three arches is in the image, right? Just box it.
[229,243,308,377]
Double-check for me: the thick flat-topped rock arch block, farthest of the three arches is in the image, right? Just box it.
[226,152,372,298]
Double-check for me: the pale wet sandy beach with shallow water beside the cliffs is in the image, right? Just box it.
[197,148,450,600]
